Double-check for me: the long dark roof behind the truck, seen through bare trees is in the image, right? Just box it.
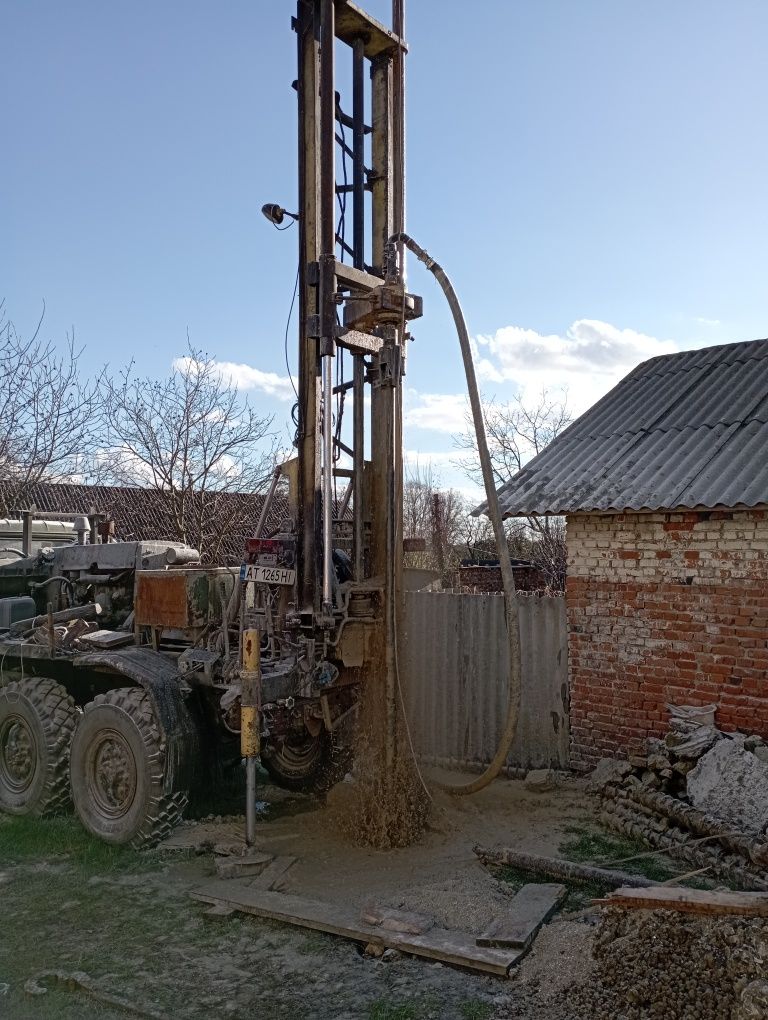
[0,481,287,563]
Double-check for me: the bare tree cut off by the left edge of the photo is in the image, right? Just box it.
[0,302,98,514]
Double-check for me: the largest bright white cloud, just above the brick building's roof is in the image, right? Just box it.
[473,319,678,414]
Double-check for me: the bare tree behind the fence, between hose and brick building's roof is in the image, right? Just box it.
[454,390,573,591]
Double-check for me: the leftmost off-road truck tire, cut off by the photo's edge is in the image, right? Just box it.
[0,677,78,817]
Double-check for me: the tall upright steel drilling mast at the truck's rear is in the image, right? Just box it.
[244,0,421,820]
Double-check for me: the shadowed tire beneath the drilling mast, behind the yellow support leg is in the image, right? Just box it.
[261,729,351,794]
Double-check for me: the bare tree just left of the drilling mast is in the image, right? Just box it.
[95,347,274,562]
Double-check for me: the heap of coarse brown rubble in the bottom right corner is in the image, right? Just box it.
[563,908,768,1020]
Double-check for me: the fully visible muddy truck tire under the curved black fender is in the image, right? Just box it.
[69,687,188,849]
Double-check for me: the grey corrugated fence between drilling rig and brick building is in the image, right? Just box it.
[400,592,568,770]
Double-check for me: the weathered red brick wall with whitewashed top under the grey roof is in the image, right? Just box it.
[567,510,768,764]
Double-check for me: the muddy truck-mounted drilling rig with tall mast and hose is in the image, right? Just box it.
[0,0,519,846]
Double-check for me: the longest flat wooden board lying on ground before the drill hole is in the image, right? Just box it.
[191,881,522,977]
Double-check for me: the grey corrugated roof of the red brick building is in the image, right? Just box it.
[475,340,768,516]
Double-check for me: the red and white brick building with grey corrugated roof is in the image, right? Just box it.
[481,340,768,765]
